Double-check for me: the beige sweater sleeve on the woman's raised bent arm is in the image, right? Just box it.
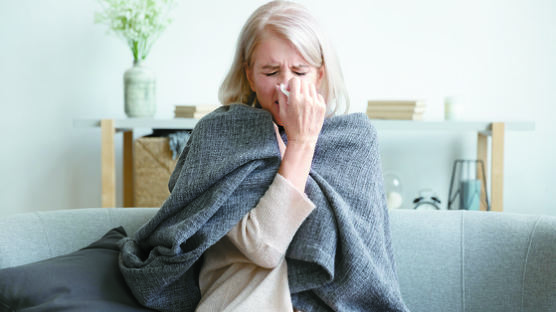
[227,174,315,268]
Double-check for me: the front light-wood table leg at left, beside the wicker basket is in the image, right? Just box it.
[100,119,116,208]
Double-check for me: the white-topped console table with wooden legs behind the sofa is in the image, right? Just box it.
[74,118,535,211]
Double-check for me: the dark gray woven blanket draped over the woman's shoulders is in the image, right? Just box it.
[120,104,407,312]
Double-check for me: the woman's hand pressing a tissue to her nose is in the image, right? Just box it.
[276,77,326,146]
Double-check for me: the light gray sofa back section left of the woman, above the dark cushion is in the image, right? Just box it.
[0,208,158,268]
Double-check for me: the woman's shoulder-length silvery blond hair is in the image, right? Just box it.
[218,0,349,116]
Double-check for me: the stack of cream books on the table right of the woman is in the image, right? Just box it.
[367,100,426,120]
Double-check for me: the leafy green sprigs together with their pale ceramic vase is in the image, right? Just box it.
[95,0,177,117]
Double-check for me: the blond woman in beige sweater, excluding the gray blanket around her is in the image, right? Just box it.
[197,1,347,311]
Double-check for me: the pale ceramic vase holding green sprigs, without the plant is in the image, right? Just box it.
[124,61,156,117]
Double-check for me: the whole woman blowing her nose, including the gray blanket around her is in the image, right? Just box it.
[120,1,406,311]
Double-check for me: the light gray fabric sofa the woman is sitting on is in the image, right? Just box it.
[0,208,556,312]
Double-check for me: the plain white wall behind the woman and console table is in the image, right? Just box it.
[0,0,556,215]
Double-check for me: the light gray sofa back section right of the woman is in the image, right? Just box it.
[390,211,556,312]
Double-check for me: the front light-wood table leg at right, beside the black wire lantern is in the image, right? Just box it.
[490,122,504,211]
